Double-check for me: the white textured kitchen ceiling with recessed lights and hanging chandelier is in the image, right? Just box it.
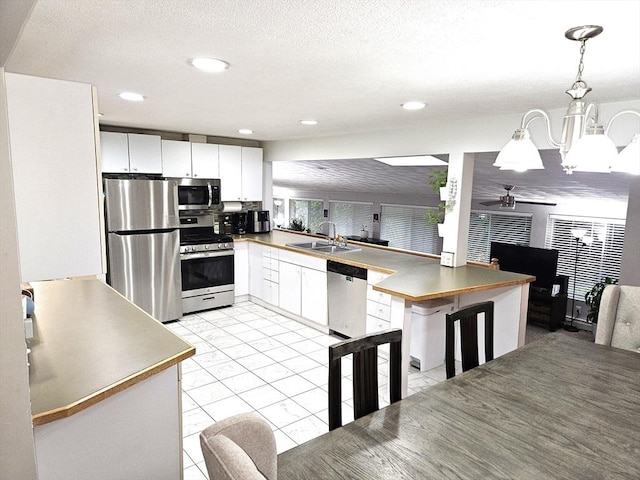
[1,0,640,140]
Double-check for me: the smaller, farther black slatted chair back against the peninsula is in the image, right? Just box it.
[445,301,493,378]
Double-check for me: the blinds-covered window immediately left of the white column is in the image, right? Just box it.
[380,205,440,255]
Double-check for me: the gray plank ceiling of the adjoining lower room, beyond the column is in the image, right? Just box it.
[273,150,632,204]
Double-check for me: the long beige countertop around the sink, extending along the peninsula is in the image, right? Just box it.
[234,230,535,302]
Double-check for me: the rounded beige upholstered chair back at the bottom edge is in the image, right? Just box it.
[200,413,278,480]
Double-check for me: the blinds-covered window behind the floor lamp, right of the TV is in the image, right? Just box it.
[544,215,625,300]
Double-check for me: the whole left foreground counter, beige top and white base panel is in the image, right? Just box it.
[29,279,195,480]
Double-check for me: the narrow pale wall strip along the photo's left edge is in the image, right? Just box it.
[0,68,37,480]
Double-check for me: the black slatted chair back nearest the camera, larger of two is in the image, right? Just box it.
[329,329,402,430]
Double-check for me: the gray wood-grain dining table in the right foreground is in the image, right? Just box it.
[278,332,640,480]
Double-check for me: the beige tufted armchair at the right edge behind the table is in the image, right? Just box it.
[595,285,640,353]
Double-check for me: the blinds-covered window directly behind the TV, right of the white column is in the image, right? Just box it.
[467,212,531,263]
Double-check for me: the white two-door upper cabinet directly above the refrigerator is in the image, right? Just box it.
[100,132,162,174]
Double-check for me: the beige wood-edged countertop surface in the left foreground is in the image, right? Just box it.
[29,279,195,425]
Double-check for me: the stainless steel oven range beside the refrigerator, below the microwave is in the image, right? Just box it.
[180,215,235,313]
